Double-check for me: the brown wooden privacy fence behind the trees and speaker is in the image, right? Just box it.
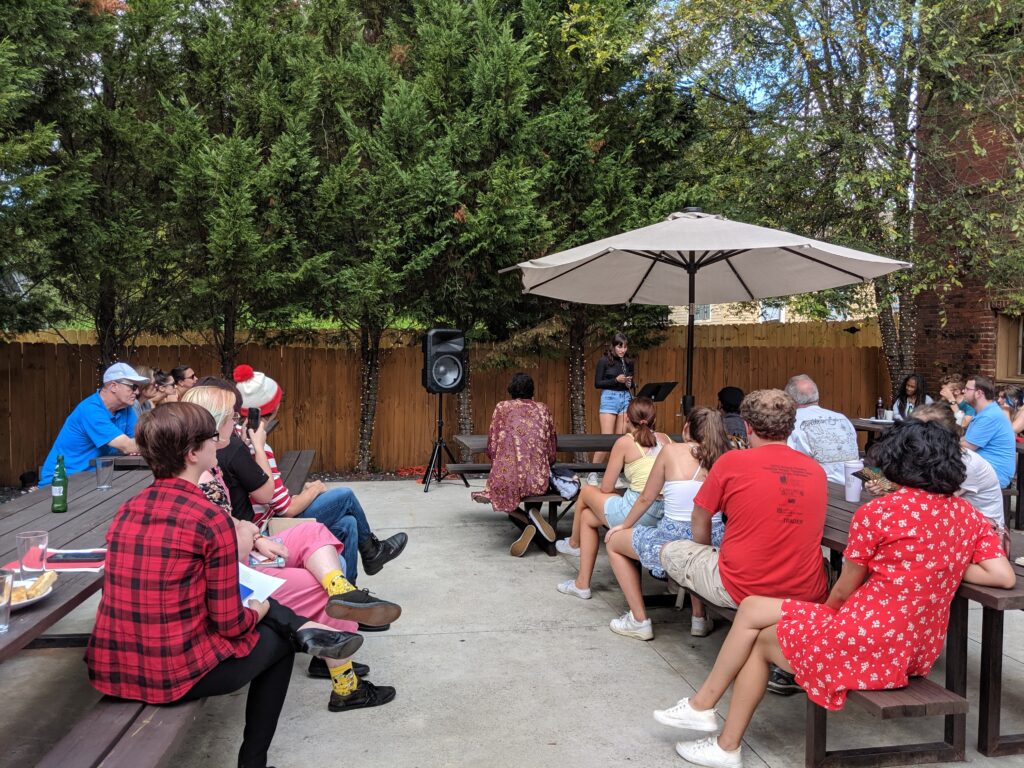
[0,323,889,485]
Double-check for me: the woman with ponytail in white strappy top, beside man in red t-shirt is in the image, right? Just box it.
[604,408,729,640]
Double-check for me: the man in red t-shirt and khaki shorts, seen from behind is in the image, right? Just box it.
[662,389,828,618]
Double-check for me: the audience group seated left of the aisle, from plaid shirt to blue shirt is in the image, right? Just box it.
[41,362,408,768]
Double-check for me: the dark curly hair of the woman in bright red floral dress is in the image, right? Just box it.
[872,419,967,496]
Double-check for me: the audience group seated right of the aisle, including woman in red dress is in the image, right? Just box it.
[473,374,1024,768]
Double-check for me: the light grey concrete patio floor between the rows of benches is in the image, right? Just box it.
[0,480,1024,768]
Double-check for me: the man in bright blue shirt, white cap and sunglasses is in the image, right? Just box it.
[39,362,150,485]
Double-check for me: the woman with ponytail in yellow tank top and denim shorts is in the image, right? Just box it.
[557,397,672,600]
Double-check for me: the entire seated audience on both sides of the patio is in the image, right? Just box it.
[36,362,1024,768]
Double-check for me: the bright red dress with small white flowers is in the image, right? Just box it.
[778,487,1002,710]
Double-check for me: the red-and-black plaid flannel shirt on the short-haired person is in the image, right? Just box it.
[85,478,258,703]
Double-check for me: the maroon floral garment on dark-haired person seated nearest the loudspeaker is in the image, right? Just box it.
[484,399,557,512]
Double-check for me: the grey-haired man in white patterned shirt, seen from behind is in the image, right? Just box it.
[785,374,859,482]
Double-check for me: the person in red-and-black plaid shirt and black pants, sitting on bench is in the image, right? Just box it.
[85,402,361,768]
